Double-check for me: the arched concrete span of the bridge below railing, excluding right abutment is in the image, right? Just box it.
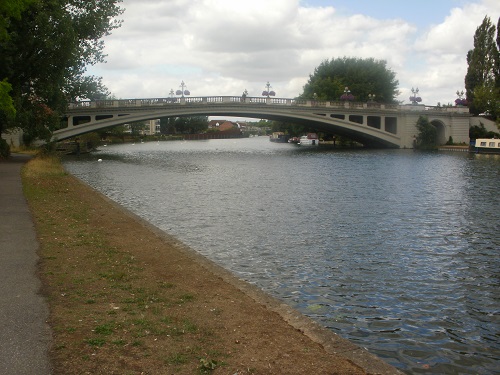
[53,104,401,148]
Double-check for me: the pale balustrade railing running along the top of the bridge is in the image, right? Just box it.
[68,96,469,113]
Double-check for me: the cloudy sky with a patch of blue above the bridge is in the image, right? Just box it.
[89,0,500,105]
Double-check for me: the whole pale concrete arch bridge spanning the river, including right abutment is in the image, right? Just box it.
[52,96,470,148]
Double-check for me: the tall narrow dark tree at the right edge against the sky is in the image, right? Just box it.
[465,16,500,118]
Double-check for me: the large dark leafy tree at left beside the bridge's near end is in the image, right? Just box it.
[0,0,123,150]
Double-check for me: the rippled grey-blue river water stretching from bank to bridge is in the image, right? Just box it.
[65,137,500,374]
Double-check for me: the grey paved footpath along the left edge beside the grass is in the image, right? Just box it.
[0,154,51,375]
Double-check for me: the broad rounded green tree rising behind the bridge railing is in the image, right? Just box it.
[300,57,399,103]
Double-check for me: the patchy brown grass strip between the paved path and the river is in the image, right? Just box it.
[22,157,364,374]
